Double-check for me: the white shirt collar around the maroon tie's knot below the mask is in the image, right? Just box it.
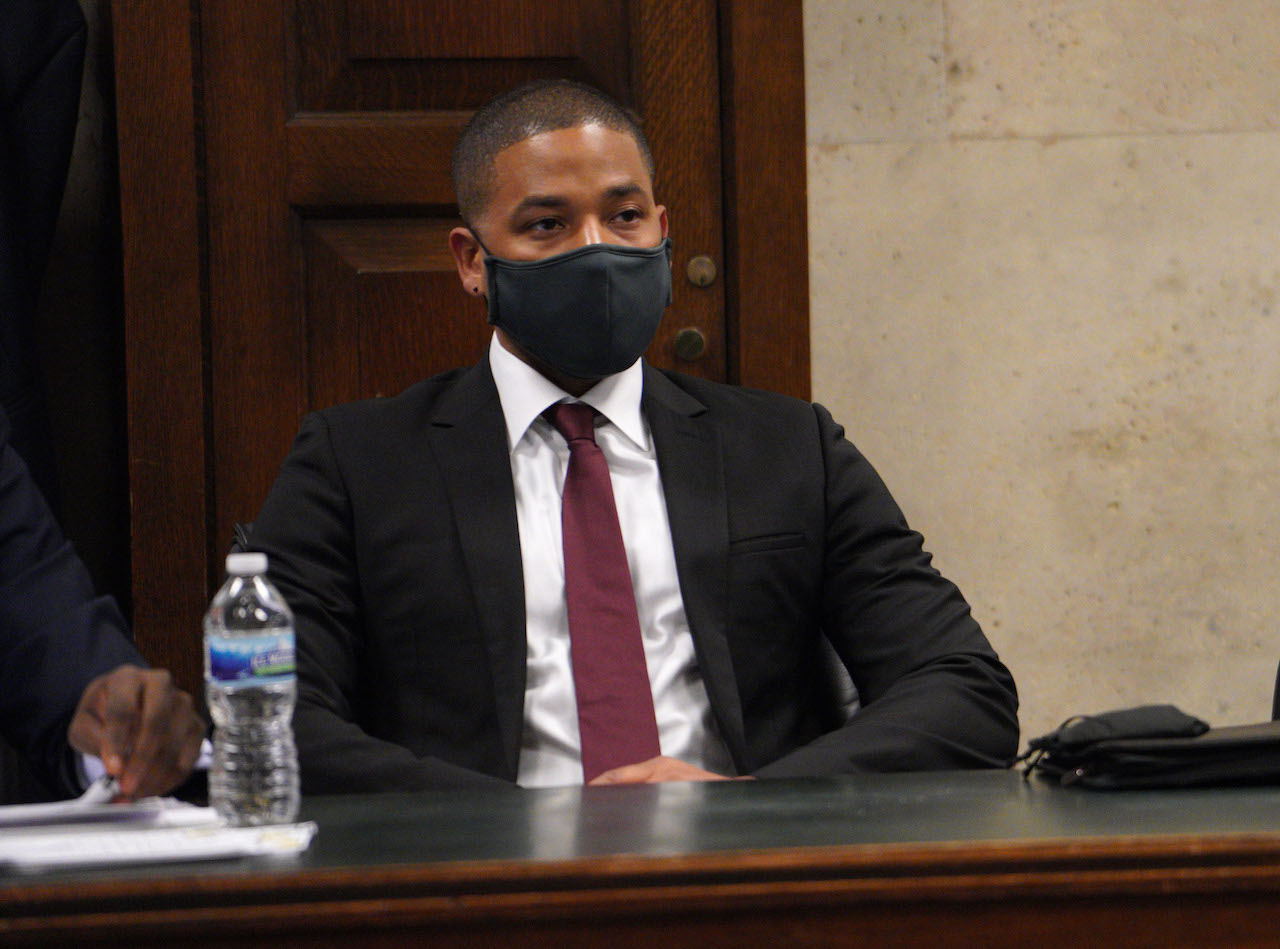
[489,334,649,451]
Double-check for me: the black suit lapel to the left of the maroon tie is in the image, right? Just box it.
[428,360,526,780]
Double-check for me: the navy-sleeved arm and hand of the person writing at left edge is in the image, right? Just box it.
[0,410,205,799]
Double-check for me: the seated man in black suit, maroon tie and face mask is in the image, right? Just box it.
[253,82,1018,793]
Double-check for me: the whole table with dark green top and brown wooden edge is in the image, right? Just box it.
[0,771,1280,949]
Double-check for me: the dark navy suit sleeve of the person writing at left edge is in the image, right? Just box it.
[0,412,146,795]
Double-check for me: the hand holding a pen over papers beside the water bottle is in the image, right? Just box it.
[67,665,205,800]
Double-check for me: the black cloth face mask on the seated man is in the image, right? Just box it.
[484,238,671,379]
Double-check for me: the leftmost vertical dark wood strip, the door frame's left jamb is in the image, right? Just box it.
[113,0,210,689]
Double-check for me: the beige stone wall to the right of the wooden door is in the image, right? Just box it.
[805,0,1280,739]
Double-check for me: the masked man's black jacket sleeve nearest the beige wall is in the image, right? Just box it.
[755,405,1019,777]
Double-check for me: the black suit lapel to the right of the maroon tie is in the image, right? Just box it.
[644,364,746,767]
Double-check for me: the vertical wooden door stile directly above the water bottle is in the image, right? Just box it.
[198,0,300,609]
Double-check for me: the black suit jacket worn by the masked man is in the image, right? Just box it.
[253,361,1018,793]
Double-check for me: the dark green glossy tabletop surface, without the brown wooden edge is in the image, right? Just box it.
[0,771,1280,895]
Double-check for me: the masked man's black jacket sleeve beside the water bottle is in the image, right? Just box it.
[252,414,512,794]
